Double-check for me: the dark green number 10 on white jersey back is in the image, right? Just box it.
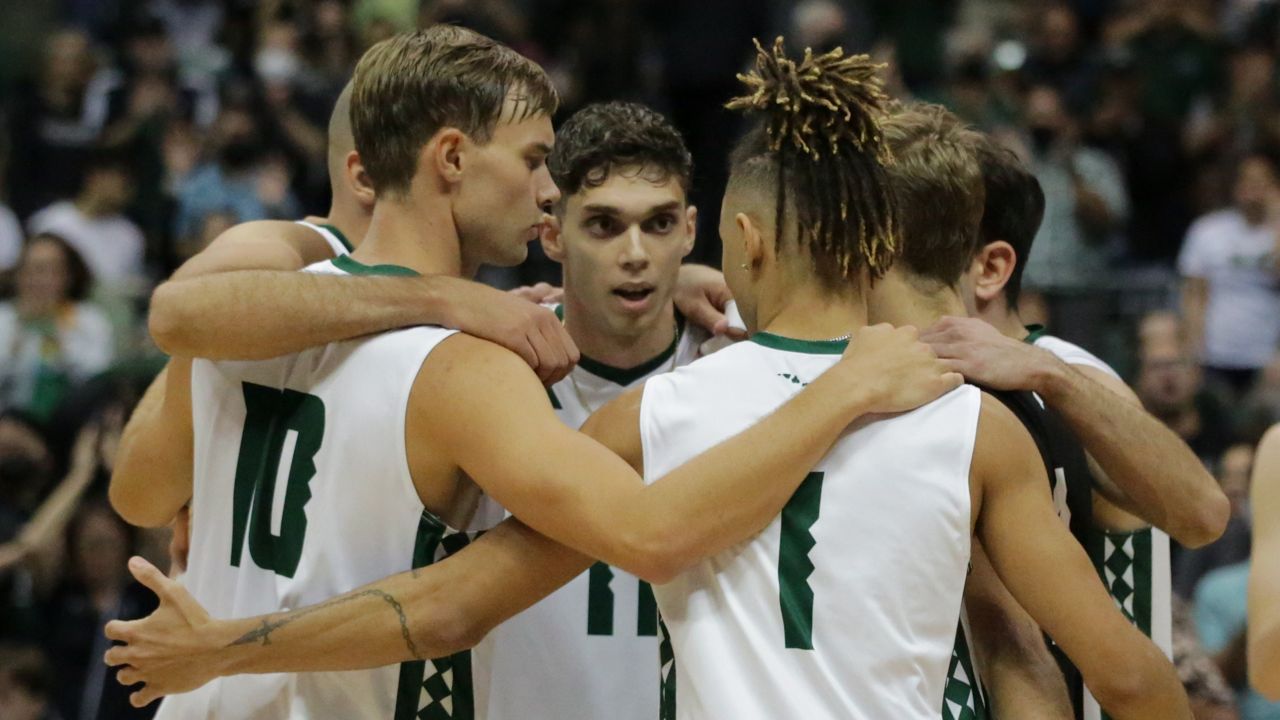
[232,383,324,578]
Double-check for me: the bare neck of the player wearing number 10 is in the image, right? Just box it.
[351,197,462,277]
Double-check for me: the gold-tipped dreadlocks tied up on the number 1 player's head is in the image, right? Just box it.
[728,37,899,288]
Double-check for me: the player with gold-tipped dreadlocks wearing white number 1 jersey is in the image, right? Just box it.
[99,41,1190,720]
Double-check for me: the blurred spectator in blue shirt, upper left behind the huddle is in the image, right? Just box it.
[174,108,302,238]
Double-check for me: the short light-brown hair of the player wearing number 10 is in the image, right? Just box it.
[351,24,559,193]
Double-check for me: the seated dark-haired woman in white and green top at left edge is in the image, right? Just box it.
[0,234,113,419]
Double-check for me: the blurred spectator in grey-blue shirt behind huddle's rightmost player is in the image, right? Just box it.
[1025,85,1129,348]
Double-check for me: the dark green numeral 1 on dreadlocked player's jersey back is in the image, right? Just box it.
[778,473,823,650]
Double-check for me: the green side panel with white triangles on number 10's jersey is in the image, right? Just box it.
[396,511,475,720]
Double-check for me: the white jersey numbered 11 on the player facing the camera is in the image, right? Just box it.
[472,306,708,720]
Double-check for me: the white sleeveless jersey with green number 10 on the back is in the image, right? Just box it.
[157,255,466,720]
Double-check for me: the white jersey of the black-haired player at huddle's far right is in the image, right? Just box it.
[1030,325,1174,720]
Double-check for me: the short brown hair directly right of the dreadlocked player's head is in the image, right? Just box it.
[882,102,986,290]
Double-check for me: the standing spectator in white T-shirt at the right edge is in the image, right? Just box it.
[1178,152,1280,396]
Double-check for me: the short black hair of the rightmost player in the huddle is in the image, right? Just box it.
[978,137,1044,307]
